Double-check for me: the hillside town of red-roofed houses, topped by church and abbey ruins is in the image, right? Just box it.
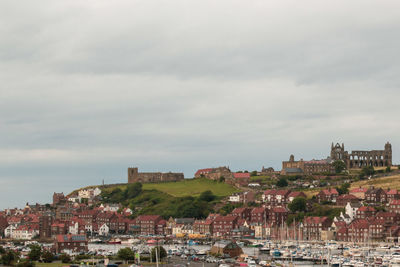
[0,143,400,266]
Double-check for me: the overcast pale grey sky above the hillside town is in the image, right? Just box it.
[0,0,400,209]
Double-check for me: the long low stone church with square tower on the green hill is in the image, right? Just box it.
[128,168,185,183]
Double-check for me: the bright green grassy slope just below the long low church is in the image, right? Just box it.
[99,178,239,197]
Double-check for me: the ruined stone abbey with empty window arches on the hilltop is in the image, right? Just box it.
[331,142,392,169]
